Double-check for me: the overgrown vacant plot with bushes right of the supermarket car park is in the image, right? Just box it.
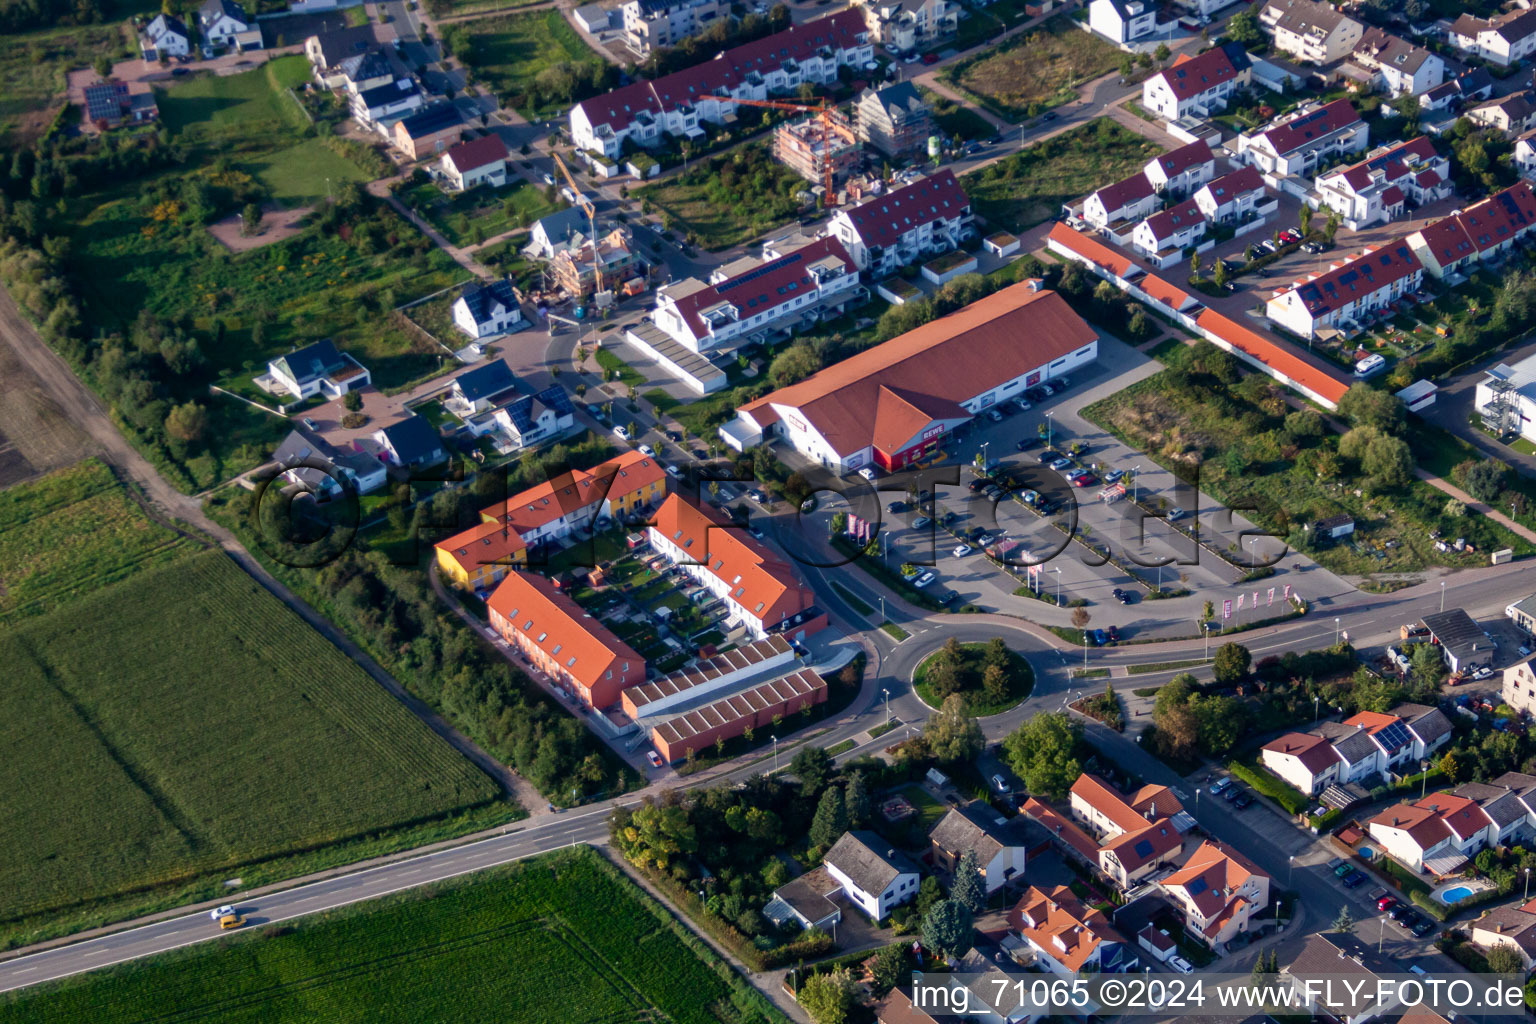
[1083,342,1528,574]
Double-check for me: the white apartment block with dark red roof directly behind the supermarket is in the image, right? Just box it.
[651,238,859,353]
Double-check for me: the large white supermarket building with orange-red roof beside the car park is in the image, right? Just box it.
[720,281,1098,473]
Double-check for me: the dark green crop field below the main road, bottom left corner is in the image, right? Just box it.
[0,849,785,1024]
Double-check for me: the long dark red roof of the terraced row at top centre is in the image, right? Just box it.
[576,8,868,132]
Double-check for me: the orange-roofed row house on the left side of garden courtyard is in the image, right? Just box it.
[485,571,645,709]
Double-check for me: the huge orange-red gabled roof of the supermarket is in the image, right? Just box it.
[742,281,1098,454]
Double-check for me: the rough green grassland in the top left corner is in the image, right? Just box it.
[0,11,129,149]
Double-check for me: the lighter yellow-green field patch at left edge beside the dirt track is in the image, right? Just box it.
[0,459,192,623]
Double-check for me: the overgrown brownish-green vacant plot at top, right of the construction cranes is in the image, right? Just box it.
[942,17,1121,121]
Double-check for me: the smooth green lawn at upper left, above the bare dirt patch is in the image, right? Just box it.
[158,54,309,137]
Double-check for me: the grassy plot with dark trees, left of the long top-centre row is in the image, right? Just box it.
[455,9,604,117]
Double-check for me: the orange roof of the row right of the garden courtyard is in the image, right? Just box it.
[651,494,816,629]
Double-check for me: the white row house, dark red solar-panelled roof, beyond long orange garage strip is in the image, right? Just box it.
[1264,239,1424,338]
